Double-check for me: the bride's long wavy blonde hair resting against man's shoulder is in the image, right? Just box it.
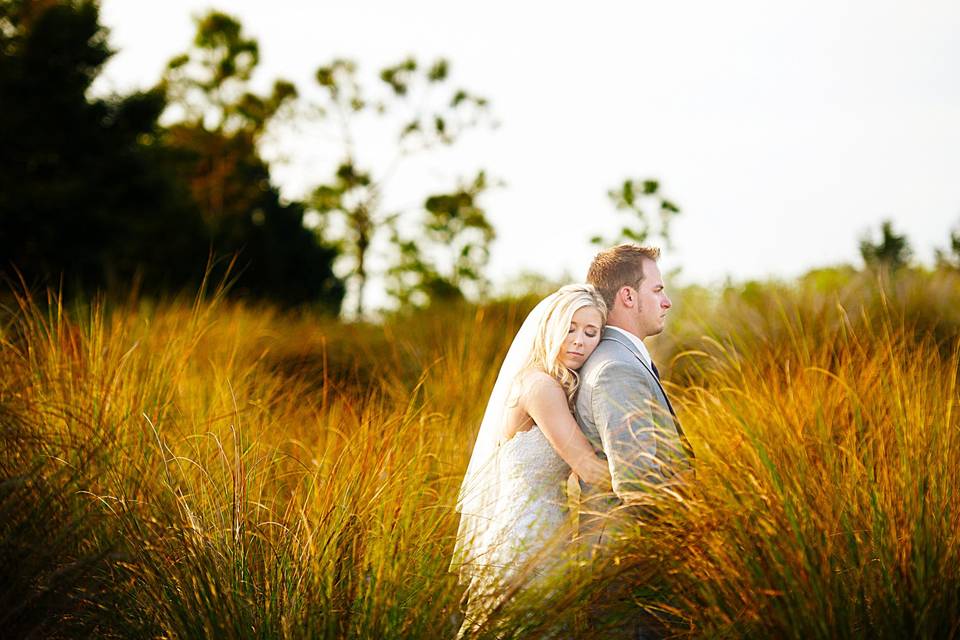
[524,284,607,405]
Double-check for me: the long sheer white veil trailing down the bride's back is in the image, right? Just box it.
[450,295,553,584]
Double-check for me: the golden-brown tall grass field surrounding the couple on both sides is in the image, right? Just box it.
[0,271,960,638]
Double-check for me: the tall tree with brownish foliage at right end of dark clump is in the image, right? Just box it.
[160,11,344,313]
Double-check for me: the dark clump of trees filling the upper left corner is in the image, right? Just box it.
[0,0,343,312]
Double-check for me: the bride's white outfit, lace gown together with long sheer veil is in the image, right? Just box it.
[450,297,571,638]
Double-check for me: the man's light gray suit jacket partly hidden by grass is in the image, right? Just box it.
[574,328,692,536]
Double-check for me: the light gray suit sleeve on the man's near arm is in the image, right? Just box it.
[592,362,663,503]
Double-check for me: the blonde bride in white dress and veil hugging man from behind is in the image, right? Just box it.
[451,284,610,638]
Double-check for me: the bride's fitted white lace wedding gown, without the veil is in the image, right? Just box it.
[458,425,570,637]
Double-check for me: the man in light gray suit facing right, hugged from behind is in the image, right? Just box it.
[575,244,693,636]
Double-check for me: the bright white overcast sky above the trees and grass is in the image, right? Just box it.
[99,0,960,304]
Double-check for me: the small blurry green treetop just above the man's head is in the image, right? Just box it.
[590,178,680,247]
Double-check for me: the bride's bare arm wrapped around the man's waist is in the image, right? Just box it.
[521,374,610,485]
